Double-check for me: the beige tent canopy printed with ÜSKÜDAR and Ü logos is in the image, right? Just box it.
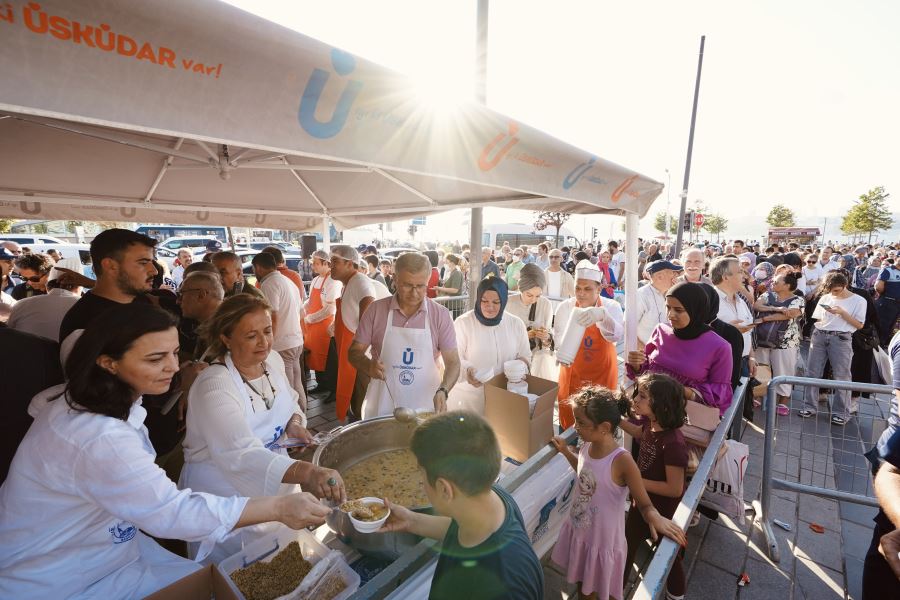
[0,0,663,230]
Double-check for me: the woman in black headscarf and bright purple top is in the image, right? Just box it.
[627,282,733,414]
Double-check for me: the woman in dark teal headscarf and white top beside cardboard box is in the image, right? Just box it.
[447,276,531,415]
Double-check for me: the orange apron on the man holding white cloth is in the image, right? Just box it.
[557,298,619,430]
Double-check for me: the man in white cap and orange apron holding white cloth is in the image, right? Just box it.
[553,260,625,430]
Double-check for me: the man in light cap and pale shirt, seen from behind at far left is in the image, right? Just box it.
[6,258,82,342]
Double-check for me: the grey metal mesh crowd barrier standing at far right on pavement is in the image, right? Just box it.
[760,375,893,562]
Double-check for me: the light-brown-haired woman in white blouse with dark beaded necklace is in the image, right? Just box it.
[178,294,344,562]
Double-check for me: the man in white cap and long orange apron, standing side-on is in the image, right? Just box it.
[331,244,375,421]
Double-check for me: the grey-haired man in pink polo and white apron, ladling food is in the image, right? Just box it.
[349,253,459,419]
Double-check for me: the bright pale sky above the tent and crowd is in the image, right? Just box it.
[221,0,900,244]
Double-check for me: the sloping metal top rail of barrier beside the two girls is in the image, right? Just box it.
[626,377,749,600]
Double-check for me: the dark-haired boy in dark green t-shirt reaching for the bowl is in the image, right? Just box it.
[380,411,544,600]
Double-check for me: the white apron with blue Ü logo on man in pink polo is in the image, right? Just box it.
[362,300,441,420]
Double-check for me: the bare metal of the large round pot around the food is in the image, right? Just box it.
[312,416,431,560]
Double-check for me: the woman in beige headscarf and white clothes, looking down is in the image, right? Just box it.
[506,263,559,380]
